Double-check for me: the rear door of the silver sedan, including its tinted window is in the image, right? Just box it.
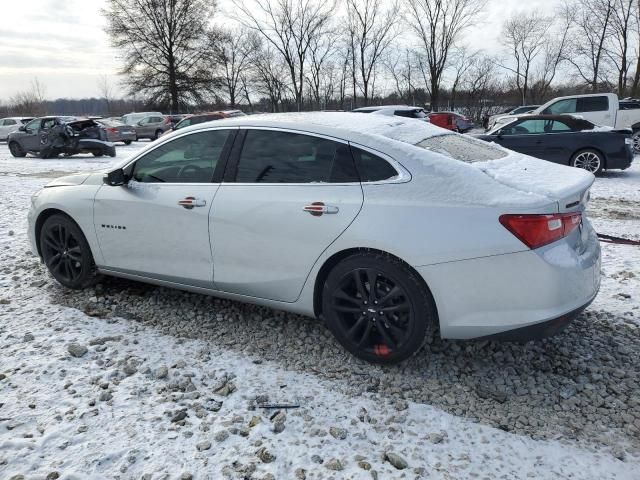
[211,128,363,302]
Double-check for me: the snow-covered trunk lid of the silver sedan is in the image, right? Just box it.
[472,153,595,213]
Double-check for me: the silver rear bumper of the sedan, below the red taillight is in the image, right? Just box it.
[417,221,600,340]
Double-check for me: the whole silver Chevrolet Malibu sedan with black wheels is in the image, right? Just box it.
[29,112,600,363]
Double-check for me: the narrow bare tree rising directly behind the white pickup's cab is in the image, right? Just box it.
[568,0,616,92]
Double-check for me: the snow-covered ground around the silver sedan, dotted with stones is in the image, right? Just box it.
[0,143,640,479]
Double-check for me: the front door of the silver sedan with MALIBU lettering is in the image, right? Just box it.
[94,130,235,288]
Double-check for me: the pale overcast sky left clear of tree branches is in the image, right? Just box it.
[0,0,558,102]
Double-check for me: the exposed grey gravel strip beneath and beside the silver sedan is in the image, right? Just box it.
[39,267,640,457]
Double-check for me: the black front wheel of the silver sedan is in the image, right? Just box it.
[39,215,95,290]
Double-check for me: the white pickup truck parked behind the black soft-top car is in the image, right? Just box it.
[491,93,640,153]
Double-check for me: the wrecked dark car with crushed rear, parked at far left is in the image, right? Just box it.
[7,117,116,158]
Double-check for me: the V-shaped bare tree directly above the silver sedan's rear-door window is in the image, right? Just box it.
[232,0,333,110]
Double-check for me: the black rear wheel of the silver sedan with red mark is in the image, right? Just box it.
[322,253,437,365]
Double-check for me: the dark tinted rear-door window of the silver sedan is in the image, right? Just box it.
[236,130,359,183]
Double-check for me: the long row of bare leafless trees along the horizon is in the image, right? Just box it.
[0,0,640,119]
